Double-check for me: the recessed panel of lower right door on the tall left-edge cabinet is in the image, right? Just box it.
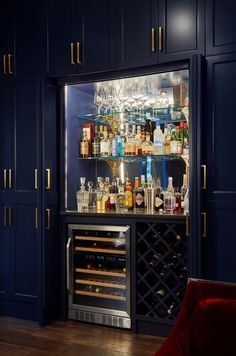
[12,205,37,300]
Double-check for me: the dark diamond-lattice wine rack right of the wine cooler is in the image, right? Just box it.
[136,222,187,324]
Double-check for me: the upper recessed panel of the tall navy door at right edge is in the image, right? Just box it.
[207,60,236,195]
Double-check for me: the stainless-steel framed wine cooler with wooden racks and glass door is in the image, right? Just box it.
[67,224,131,328]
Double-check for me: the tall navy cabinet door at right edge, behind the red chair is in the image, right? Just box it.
[203,54,236,283]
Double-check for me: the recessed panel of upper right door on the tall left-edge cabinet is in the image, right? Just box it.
[12,82,38,191]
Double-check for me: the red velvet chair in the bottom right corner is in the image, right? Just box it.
[155,279,236,356]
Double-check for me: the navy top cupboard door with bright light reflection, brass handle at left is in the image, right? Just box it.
[158,0,204,62]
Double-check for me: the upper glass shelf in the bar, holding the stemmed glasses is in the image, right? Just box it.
[77,106,188,125]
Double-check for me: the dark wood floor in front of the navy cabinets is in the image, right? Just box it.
[0,317,164,356]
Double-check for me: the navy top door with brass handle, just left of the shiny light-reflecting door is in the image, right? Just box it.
[115,0,158,67]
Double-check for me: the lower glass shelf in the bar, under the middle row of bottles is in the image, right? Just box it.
[78,153,187,162]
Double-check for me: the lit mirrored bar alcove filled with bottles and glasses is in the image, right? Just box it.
[65,70,189,215]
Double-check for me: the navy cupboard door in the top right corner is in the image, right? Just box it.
[206,0,236,55]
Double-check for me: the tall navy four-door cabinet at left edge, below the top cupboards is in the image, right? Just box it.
[0,80,40,319]
